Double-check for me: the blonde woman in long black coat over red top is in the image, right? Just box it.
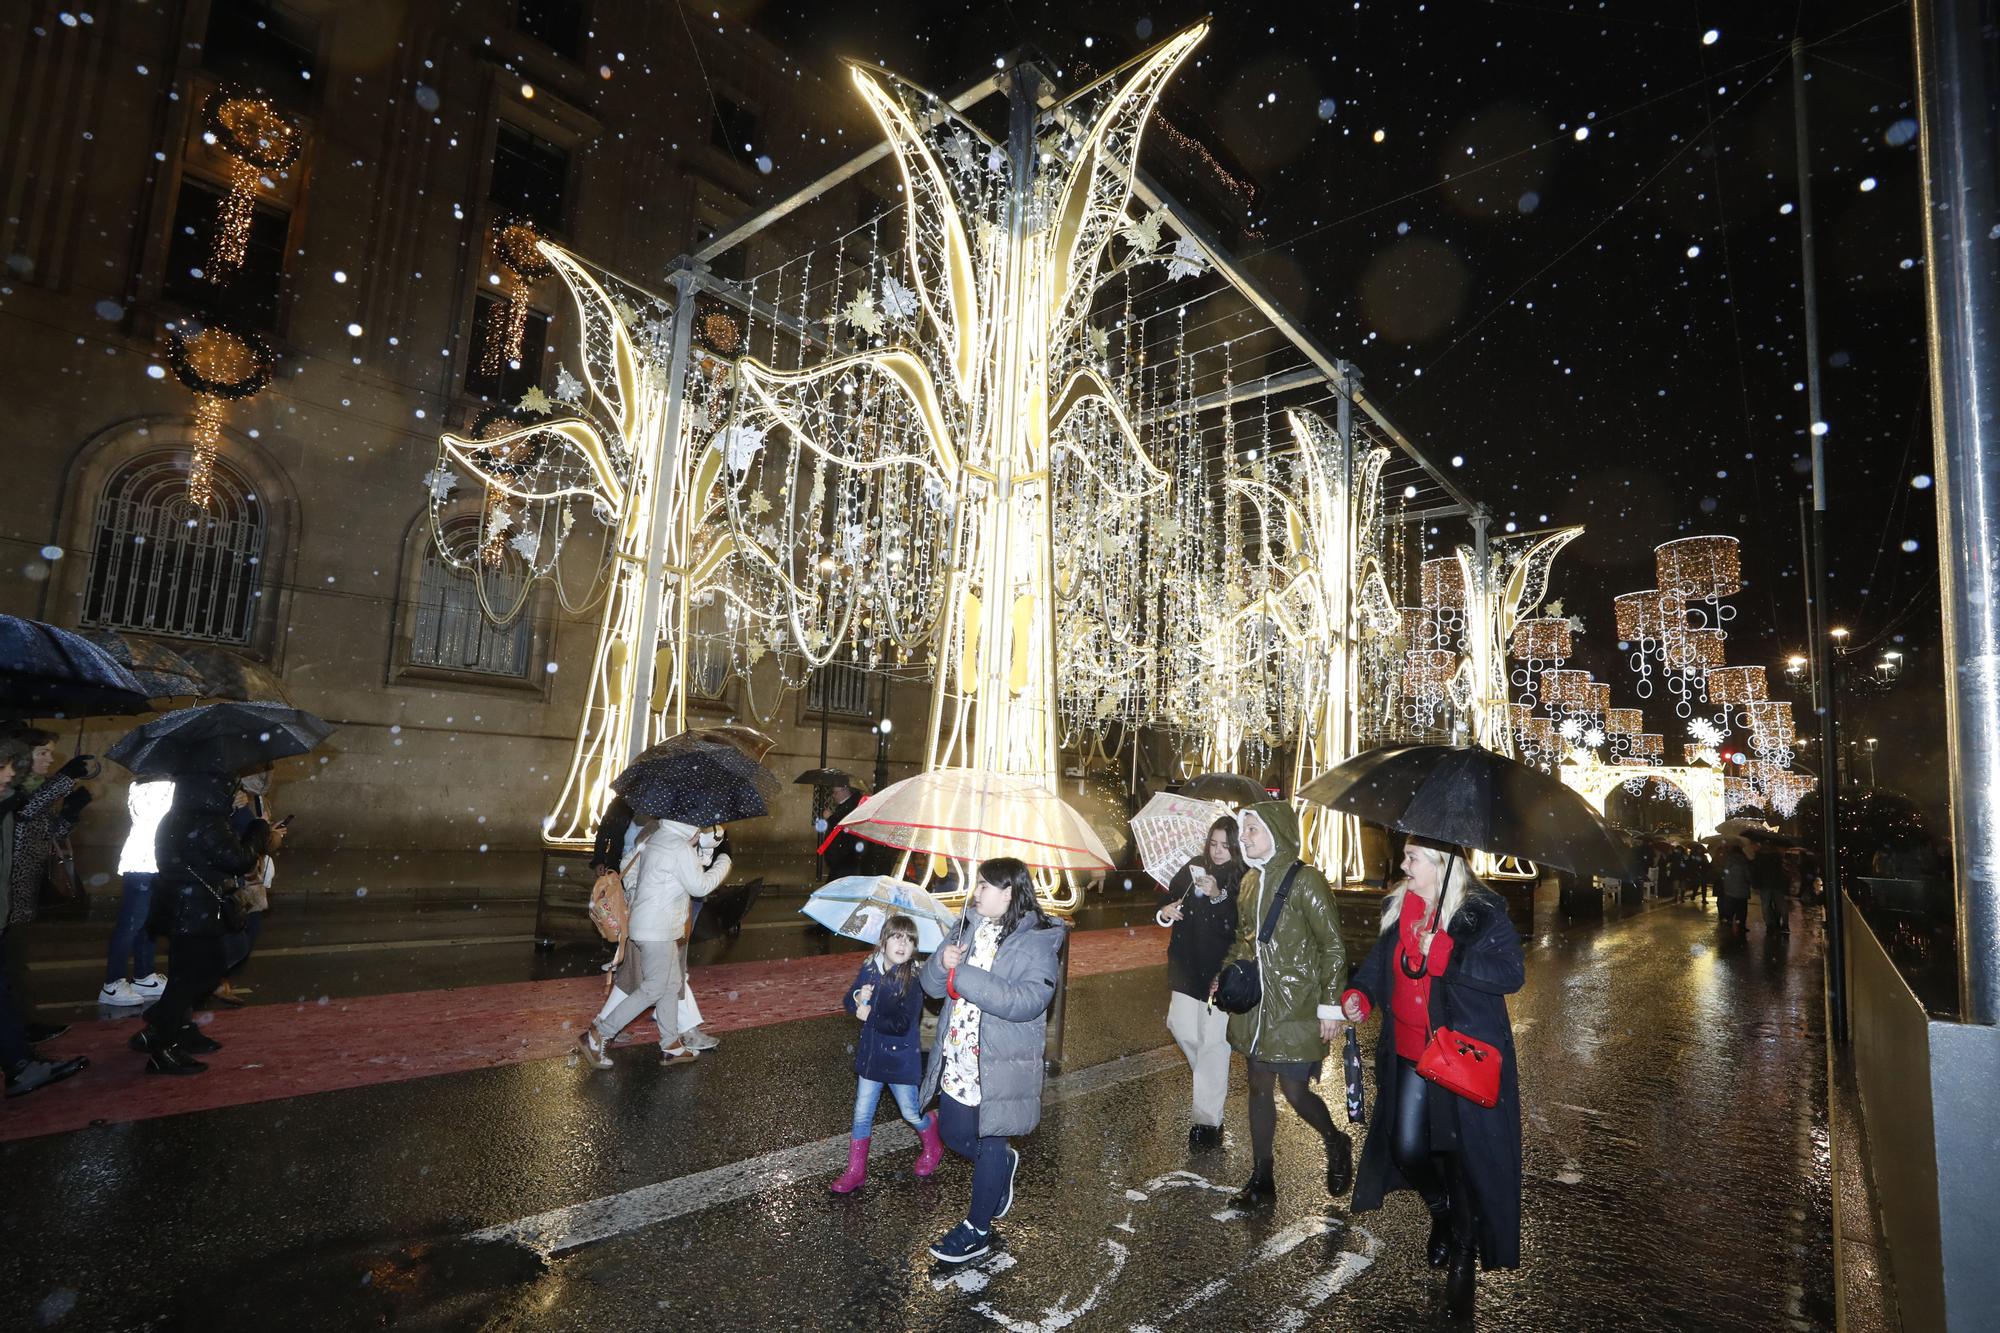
[1340,841,1524,1317]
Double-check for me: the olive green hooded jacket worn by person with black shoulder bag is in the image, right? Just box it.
[1222,801,1348,1065]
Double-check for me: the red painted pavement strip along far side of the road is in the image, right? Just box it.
[0,927,1166,1141]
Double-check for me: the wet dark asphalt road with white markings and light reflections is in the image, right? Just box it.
[0,892,1832,1333]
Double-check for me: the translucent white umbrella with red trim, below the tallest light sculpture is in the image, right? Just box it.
[828,769,1112,871]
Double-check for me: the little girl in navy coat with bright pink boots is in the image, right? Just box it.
[828,915,944,1195]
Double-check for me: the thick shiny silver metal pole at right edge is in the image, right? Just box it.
[1910,0,2000,1023]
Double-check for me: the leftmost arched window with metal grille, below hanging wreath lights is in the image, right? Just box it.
[84,450,264,642]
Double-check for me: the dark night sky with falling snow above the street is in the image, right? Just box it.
[738,0,1942,805]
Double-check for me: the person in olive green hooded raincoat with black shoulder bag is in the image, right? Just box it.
[1224,801,1354,1211]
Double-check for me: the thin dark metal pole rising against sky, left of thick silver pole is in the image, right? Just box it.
[1792,38,1848,1045]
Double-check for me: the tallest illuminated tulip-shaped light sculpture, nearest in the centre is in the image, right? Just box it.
[740,24,1206,777]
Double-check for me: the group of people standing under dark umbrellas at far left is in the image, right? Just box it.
[0,727,288,1097]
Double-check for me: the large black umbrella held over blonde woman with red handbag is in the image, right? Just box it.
[1298,745,1628,879]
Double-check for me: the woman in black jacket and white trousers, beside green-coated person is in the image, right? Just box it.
[1156,815,1246,1153]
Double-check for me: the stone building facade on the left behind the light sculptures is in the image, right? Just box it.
[0,0,924,897]
